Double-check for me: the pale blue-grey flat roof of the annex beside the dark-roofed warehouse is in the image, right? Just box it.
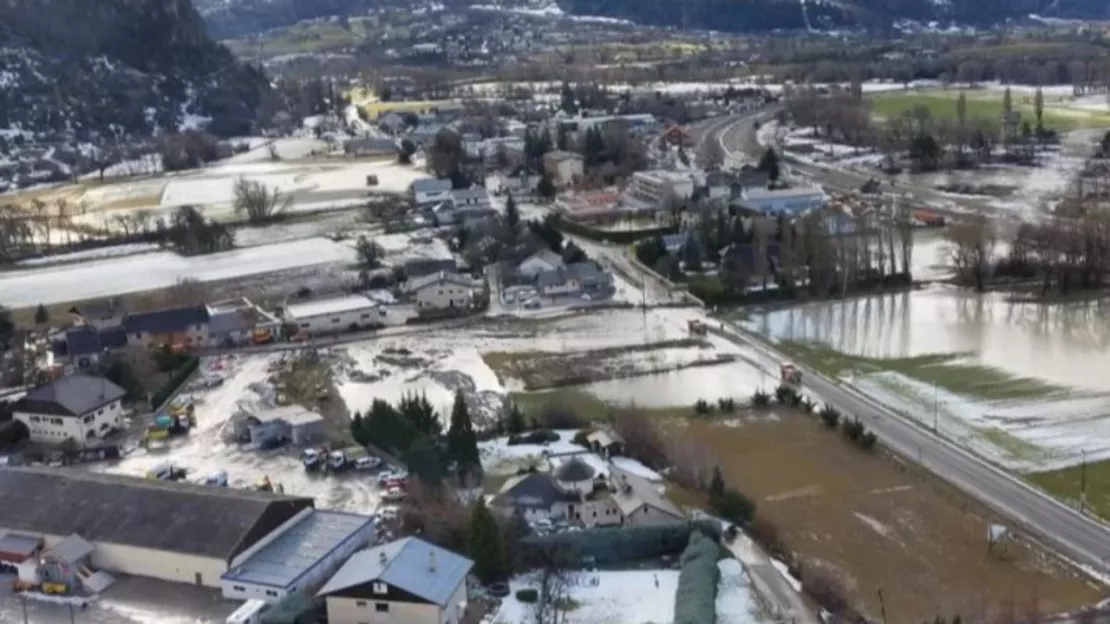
[221,510,374,587]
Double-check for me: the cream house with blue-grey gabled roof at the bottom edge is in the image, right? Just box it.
[316,537,474,624]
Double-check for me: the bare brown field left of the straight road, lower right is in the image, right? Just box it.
[675,412,1106,624]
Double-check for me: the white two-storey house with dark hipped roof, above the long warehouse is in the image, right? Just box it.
[13,374,127,447]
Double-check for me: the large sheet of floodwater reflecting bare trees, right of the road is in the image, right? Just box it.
[747,286,1110,391]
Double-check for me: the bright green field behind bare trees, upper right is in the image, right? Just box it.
[867,90,1110,130]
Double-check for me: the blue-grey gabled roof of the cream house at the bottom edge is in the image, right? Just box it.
[316,537,474,606]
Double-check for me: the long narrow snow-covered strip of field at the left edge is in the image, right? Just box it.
[0,239,355,308]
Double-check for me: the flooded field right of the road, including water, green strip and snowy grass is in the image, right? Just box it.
[743,286,1110,471]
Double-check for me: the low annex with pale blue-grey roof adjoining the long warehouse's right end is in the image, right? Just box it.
[221,510,375,603]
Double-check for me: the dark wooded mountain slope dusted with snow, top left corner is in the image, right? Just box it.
[0,0,269,135]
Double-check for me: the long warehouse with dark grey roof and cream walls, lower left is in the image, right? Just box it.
[0,467,313,587]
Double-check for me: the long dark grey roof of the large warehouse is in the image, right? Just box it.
[0,467,313,561]
